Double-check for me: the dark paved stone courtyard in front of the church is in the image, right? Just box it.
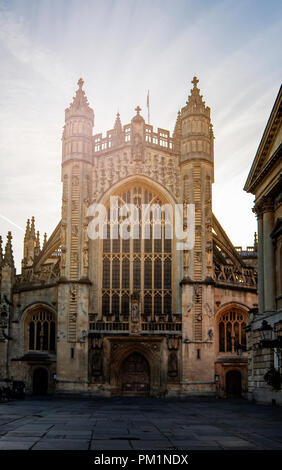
[0,398,282,450]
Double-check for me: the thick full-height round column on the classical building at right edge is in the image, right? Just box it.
[263,200,275,312]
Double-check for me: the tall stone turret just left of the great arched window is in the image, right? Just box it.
[56,79,94,391]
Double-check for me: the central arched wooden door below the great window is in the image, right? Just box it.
[121,353,150,396]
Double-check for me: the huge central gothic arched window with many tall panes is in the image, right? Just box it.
[101,184,172,317]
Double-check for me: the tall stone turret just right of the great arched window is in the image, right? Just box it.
[178,77,214,381]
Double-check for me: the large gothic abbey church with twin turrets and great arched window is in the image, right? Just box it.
[0,77,257,396]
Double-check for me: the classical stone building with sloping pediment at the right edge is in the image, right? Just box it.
[244,83,282,405]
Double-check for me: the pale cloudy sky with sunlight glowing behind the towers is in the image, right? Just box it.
[0,0,282,273]
